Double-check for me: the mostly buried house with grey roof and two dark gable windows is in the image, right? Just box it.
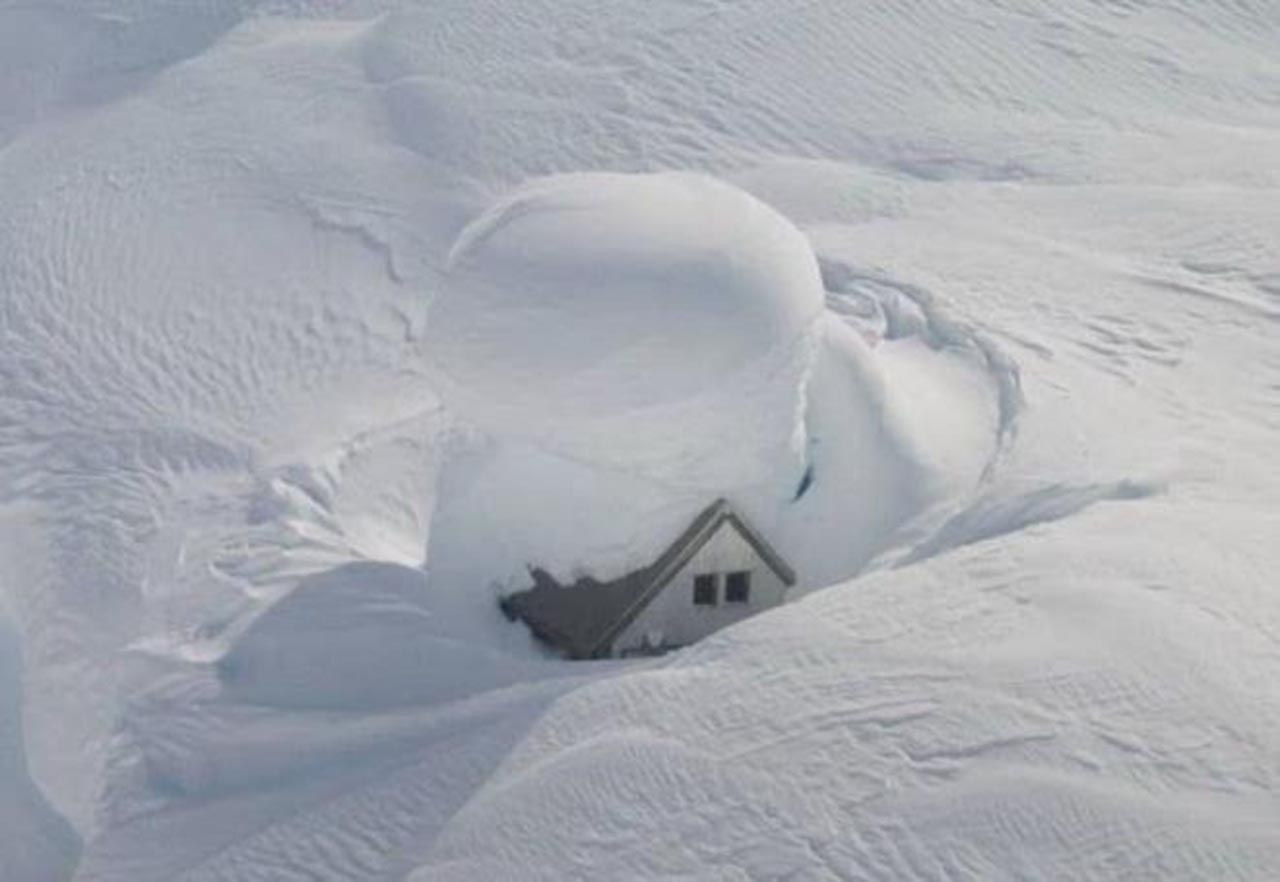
[500,499,796,658]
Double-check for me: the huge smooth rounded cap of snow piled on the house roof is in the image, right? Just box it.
[426,174,823,582]
